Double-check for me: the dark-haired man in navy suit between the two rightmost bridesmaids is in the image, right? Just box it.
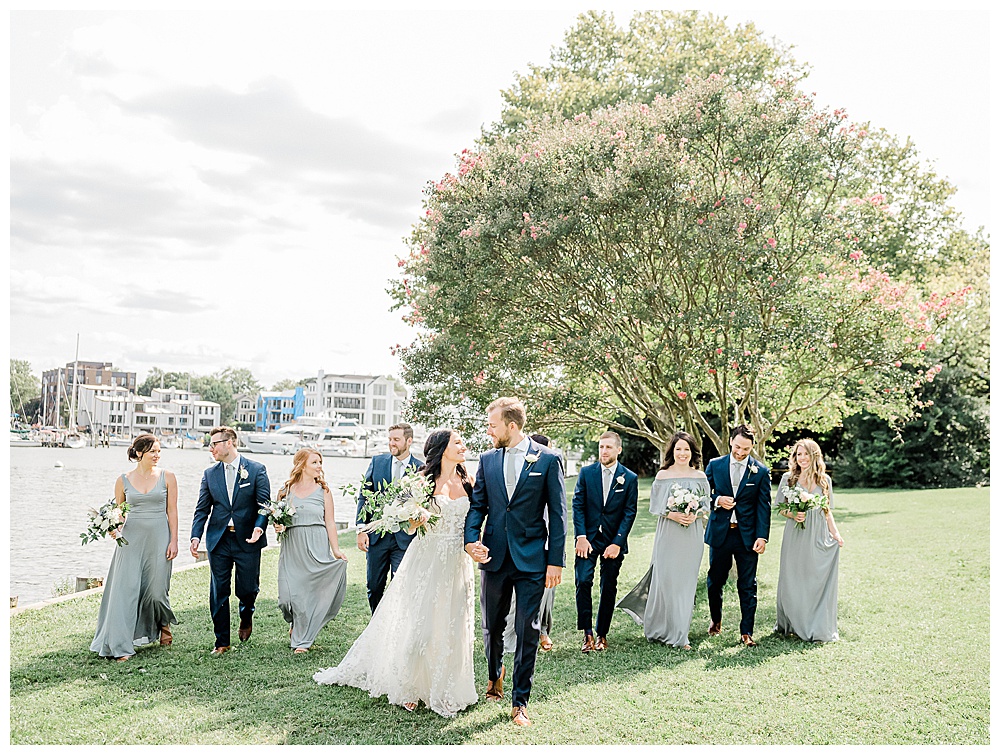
[705,425,771,647]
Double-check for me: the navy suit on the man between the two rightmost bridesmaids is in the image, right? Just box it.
[705,454,771,635]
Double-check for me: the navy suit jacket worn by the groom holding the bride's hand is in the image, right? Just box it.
[465,440,566,573]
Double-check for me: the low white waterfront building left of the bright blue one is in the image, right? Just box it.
[77,385,222,437]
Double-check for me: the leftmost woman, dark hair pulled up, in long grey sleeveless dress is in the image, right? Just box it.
[90,433,177,661]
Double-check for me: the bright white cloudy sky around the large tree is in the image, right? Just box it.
[10,3,991,386]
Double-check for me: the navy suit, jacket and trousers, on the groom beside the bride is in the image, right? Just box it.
[465,440,566,707]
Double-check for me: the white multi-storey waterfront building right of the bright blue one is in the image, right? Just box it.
[305,370,409,428]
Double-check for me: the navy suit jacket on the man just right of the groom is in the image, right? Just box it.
[573,462,639,553]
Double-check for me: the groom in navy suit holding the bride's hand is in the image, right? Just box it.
[465,398,566,726]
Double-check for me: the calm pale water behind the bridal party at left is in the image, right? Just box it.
[10,447,369,606]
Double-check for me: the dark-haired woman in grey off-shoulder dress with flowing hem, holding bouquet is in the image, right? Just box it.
[618,432,709,650]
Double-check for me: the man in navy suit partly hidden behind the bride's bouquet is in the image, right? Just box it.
[356,422,423,613]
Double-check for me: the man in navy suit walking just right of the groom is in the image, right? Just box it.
[573,430,639,653]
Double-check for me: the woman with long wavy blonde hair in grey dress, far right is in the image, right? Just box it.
[774,438,844,642]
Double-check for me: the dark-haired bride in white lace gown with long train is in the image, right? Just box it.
[313,429,478,717]
